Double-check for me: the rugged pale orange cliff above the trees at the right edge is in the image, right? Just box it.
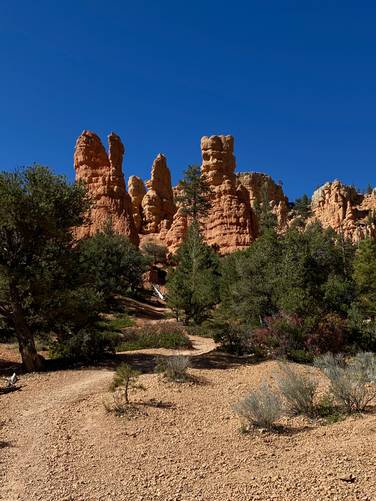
[310,180,376,242]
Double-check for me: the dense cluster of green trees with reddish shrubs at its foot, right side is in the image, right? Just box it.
[216,223,355,359]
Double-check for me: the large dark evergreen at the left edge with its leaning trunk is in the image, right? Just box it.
[0,166,90,370]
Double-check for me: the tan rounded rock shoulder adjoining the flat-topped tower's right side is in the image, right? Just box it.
[236,172,289,230]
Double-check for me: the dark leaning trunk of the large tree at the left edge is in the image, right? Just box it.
[11,287,44,372]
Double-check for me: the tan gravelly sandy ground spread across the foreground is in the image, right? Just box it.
[0,354,376,501]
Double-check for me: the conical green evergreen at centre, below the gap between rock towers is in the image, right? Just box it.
[167,221,218,323]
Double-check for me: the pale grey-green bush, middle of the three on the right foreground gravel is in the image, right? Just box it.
[278,364,317,416]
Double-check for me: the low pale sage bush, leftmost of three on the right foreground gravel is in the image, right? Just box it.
[235,382,282,430]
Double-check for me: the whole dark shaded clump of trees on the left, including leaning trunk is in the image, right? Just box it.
[0,165,150,371]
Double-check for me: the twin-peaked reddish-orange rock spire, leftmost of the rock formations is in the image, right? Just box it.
[74,131,139,245]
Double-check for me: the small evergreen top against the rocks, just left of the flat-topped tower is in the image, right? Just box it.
[176,165,211,221]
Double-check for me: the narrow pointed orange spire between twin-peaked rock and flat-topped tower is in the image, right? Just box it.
[141,153,176,233]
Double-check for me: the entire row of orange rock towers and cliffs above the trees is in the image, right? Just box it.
[74,131,376,254]
